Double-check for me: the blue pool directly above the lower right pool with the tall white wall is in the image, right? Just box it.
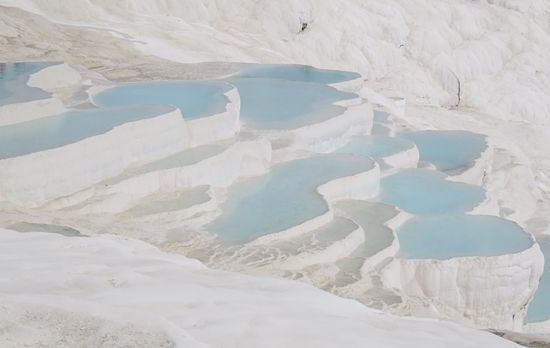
[378,169,485,215]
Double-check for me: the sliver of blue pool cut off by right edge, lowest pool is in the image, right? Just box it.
[525,236,550,323]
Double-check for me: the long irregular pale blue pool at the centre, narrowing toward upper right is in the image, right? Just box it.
[206,154,374,241]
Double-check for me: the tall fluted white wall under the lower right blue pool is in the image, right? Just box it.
[382,244,544,331]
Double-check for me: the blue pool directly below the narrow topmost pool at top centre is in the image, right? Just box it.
[227,78,357,129]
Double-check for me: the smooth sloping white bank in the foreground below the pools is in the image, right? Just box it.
[0,230,518,348]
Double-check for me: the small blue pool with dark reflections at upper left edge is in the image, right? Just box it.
[0,62,59,106]
